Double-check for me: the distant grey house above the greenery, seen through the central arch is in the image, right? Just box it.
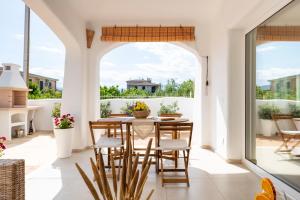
[126,78,161,93]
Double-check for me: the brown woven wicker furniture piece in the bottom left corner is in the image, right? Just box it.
[0,159,25,200]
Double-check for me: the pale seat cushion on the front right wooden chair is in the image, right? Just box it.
[157,139,190,150]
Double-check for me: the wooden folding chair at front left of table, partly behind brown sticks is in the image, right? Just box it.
[89,121,124,173]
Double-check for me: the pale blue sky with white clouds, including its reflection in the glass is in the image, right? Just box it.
[0,0,300,88]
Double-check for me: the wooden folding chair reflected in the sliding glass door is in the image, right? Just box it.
[272,114,300,153]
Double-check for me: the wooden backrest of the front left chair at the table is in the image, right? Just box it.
[89,121,124,145]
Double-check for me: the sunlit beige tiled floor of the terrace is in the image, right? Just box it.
[5,134,259,200]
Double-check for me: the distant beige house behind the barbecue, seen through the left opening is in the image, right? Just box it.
[0,67,58,90]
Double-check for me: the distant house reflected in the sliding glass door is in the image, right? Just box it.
[269,74,300,92]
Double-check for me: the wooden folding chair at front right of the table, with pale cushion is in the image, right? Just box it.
[156,122,193,186]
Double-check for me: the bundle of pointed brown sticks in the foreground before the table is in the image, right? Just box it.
[75,139,154,200]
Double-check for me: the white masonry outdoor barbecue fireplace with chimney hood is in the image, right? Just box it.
[0,63,29,140]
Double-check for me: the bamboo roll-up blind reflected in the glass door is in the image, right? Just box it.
[256,26,300,42]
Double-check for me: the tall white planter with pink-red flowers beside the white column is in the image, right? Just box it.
[54,114,74,158]
